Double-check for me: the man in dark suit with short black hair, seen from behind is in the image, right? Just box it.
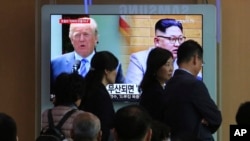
[164,40,222,141]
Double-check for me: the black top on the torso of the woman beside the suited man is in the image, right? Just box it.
[139,80,166,121]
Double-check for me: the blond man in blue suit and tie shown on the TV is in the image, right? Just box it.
[51,17,124,87]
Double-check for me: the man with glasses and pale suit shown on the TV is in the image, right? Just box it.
[125,19,186,85]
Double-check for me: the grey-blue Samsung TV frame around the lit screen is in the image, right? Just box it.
[41,5,217,111]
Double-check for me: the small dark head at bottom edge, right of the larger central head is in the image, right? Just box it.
[151,120,170,141]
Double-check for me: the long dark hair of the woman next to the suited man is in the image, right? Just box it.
[140,47,173,90]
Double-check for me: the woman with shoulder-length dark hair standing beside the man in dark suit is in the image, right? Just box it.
[139,47,173,121]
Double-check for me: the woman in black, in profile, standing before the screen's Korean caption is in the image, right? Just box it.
[79,51,118,141]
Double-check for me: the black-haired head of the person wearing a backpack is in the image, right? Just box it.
[54,73,85,106]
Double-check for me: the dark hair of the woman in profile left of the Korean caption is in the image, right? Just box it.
[86,51,118,83]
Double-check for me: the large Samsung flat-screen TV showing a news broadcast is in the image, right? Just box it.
[41,5,217,111]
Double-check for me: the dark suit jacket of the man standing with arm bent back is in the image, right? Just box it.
[164,69,222,141]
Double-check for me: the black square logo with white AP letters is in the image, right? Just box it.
[230,125,250,141]
